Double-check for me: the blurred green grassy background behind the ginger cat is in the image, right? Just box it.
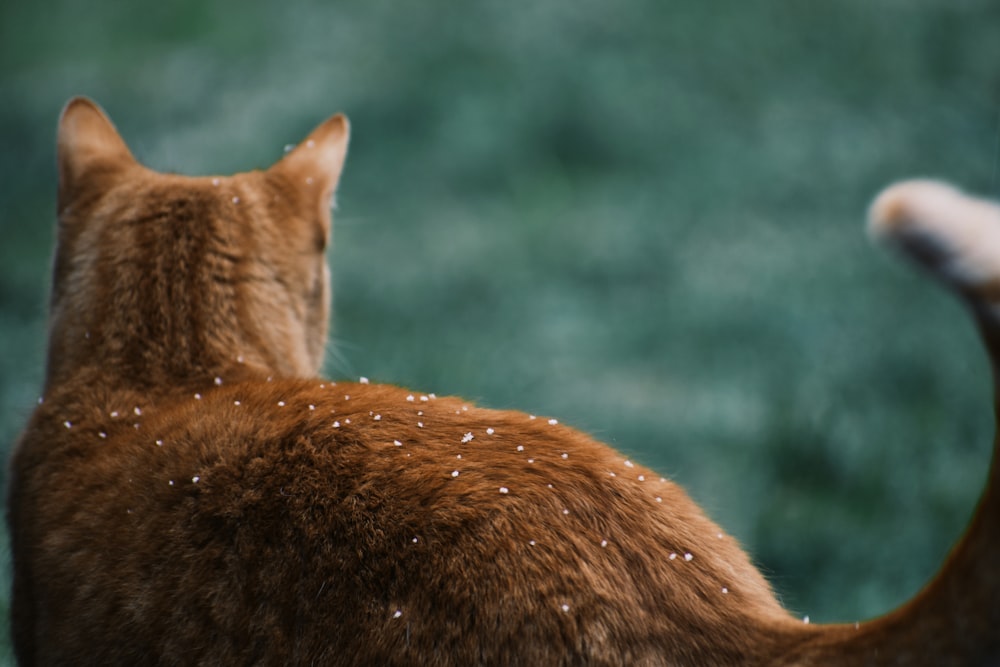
[0,0,1000,652]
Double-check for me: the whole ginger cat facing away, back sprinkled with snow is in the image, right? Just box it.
[8,99,1000,666]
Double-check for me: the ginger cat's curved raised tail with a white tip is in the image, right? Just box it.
[782,181,1000,667]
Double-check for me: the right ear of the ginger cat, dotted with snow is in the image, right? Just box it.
[268,114,351,205]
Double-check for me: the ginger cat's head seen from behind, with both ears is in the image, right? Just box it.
[47,98,349,392]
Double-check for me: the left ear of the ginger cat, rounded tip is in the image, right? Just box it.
[56,97,136,209]
